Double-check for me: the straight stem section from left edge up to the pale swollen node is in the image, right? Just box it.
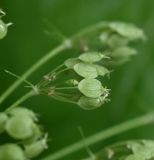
[0,42,69,104]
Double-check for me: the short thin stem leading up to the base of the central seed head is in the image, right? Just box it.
[5,90,36,112]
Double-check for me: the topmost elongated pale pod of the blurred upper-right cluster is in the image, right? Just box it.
[109,22,145,40]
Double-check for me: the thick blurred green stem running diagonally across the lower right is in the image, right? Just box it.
[42,113,154,160]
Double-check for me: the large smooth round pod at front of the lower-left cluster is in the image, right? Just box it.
[6,115,34,139]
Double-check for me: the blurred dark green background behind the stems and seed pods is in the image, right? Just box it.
[0,0,154,160]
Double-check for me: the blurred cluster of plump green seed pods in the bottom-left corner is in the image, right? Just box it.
[0,107,47,160]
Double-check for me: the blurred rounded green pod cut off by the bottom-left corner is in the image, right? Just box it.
[0,144,26,160]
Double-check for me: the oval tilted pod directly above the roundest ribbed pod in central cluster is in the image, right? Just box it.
[74,62,98,78]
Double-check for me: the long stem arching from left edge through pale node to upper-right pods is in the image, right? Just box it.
[0,22,106,104]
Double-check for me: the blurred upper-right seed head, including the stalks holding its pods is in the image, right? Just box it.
[74,22,146,66]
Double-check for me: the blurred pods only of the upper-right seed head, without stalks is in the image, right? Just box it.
[100,22,146,65]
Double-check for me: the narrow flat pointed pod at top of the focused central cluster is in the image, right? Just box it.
[79,52,105,63]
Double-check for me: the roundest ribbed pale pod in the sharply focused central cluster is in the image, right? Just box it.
[78,79,104,98]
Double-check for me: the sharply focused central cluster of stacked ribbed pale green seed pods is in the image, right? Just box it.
[64,52,110,110]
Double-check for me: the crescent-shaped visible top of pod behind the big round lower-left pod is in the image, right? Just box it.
[9,107,38,121]
